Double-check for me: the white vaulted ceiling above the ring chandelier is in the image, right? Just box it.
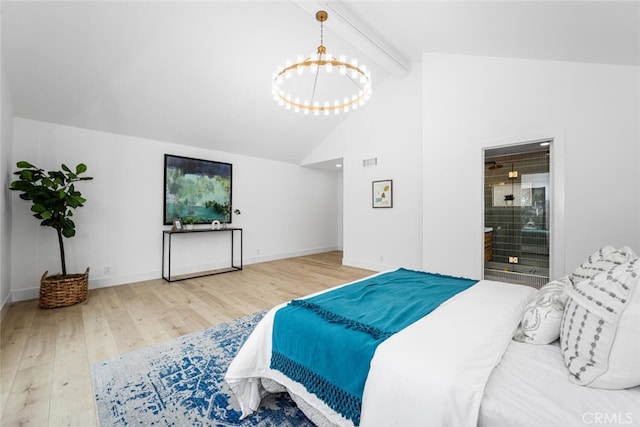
[1,0,640,163]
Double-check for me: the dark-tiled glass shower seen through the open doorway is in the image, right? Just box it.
[484,151,550,280]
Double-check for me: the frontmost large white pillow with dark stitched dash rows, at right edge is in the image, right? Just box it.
[560,258,640,389]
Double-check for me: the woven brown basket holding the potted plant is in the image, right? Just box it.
[40,268,89,308]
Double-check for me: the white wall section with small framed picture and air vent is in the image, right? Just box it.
[305,64,422,270]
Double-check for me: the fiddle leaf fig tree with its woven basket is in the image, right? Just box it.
[10,161,93,308]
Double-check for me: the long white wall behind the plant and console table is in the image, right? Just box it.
[11,118,340,300]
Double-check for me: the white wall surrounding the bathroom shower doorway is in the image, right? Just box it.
[422,54,640,278]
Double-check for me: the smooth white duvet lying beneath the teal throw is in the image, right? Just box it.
[225,280,535,427]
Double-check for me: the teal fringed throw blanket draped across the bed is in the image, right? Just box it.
[271,269,477,425]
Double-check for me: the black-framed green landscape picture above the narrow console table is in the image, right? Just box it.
[163,154,233,225]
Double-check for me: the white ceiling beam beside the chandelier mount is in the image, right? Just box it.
[291,0,411,78]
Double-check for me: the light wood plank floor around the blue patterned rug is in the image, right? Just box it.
[0,251,373,427]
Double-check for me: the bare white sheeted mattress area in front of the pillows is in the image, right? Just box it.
[478,341,640,427]
